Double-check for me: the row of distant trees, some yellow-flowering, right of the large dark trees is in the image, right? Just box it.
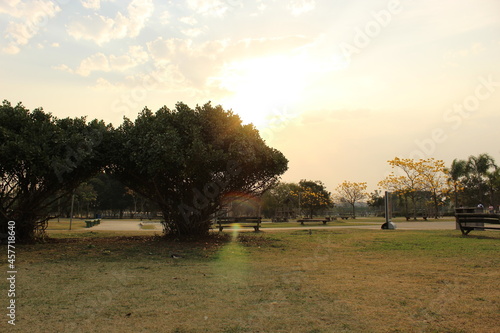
[262,154,500,219]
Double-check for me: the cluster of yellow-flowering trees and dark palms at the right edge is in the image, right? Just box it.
[379,153,500,219]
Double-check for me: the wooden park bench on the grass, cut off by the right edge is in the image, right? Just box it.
[455,208,500,235]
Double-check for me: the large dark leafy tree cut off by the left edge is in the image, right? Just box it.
[0,101,109,242]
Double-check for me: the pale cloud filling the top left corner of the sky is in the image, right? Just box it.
[0,0,61,54]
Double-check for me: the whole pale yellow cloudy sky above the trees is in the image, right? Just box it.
[0,0,500,192]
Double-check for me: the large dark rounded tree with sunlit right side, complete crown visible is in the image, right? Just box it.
[111,103,288,236]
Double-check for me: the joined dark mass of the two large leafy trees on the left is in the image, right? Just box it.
[0,101,288,242]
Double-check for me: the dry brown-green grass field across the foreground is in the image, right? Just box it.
[0,229,500,333]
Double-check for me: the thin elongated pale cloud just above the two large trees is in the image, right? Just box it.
[54,46,149,76]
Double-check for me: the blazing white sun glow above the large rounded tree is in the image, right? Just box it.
[212,56,307,127]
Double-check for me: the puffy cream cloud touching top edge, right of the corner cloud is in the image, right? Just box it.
[67,0,154,45]
